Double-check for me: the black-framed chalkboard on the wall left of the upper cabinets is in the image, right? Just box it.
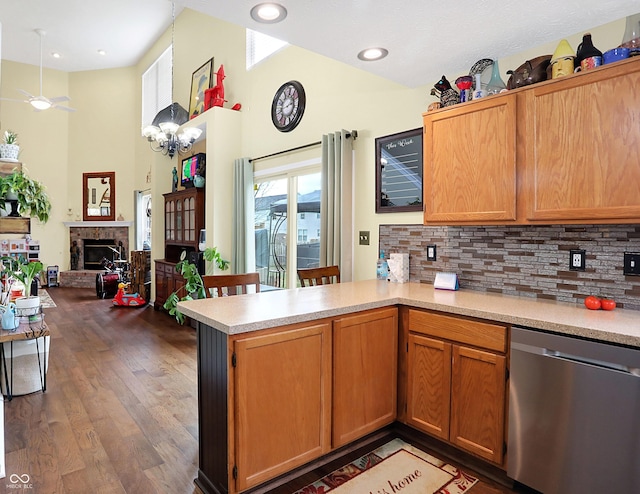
[375,127,424,213]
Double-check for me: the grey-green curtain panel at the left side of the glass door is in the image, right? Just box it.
[231,158,256,274]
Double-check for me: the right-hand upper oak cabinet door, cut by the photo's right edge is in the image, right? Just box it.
[524,61,640,222]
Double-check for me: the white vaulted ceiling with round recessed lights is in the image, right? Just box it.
[0,0,640,87]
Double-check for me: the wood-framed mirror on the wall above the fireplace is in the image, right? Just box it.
[82,172,116,221]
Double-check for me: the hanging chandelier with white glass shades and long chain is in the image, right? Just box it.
[142,2,202,158]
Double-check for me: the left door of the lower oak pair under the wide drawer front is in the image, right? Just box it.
[407,333,451,440]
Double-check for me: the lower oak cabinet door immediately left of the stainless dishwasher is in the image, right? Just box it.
[449,345,506,464]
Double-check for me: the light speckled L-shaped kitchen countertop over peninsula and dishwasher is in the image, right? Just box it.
[178,280,640,347]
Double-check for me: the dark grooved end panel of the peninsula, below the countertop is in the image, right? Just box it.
[195,323,229,494]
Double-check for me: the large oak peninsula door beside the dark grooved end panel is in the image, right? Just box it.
[234,323,331,491]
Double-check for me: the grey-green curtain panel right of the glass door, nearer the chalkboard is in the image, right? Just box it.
[320,130,353,281]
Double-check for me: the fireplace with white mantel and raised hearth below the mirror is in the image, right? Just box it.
[60,221,132,288]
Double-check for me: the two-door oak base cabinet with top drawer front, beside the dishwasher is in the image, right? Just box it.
[405,309,508,465]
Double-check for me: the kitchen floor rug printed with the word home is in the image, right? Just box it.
[295,439,478,494]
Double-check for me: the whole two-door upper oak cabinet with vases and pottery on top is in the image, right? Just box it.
[423,57,640,225]
